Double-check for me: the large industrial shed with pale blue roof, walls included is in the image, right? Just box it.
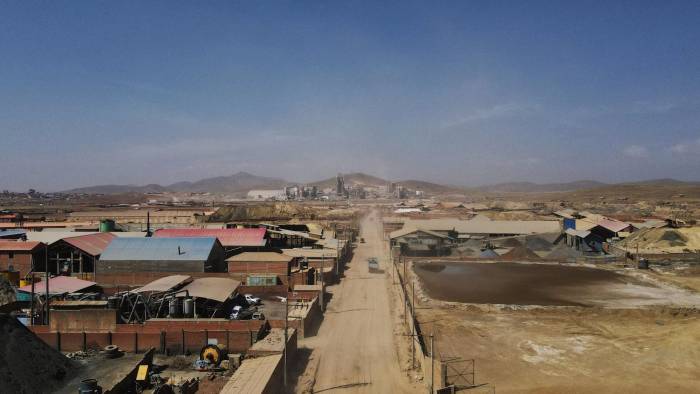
[97,237,226,273]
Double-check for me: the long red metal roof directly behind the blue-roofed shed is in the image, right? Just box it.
[153,228,267,247]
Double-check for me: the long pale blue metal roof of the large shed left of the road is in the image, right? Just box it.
[100,237,218,261]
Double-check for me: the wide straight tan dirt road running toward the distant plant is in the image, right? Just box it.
[296,212,424,393]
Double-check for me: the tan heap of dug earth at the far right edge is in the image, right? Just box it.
[619,227,700,253]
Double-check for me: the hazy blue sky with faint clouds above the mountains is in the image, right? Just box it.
[0,1,700,190]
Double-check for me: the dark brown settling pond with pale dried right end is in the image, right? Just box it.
[414,262,662,306]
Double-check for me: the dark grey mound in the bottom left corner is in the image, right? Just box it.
[0,314,75,394]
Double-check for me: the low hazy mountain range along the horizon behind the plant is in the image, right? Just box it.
[64,172,700,194]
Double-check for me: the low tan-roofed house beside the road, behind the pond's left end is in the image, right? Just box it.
[389,228,453,256]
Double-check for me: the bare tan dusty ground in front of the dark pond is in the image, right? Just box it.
[408,264,700,393]
